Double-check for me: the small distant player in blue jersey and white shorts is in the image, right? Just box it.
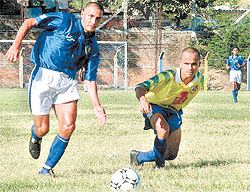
[226,47,246,103]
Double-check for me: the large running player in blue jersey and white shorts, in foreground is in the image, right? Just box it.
[6,2,106,176]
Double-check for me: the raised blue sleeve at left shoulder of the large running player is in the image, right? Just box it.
[35,12,63,30]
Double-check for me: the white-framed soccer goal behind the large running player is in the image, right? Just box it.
[0,40,128,89]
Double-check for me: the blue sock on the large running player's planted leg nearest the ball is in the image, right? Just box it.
[44,134,69,169]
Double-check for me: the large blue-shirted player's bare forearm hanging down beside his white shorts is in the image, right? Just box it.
[84,80,107,126]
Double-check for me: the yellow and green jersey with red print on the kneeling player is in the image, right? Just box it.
[136,68,204,110]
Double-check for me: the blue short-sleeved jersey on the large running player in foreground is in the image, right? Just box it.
[31,12,100,81]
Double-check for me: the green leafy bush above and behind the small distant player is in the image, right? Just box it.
[200,13,250,69]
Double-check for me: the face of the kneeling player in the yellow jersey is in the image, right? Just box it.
[180,52,200,80]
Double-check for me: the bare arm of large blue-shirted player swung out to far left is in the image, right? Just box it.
[6,18,36,62]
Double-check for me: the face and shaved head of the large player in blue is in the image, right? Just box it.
[81,6,103,32]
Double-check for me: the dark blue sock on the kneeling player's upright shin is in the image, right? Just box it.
[153,136,167,167]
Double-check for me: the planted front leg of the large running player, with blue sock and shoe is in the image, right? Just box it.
[39,101,77,176]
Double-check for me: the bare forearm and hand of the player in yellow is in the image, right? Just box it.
[135,87,151,113]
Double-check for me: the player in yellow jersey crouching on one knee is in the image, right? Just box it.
[130,47,204,168]
